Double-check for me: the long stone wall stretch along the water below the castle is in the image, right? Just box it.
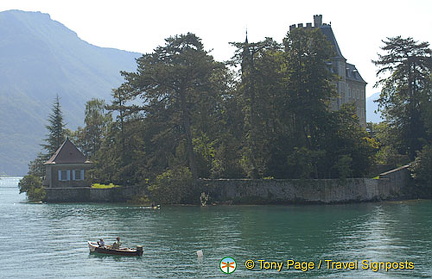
[200,166,409,204]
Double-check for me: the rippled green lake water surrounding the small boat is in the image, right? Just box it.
[0,178,432,278]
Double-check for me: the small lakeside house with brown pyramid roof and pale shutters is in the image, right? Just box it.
[43,138,92,188]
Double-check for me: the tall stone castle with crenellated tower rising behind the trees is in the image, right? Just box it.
[290,15,367,127]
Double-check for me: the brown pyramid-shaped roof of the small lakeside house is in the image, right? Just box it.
[45,138,90,165]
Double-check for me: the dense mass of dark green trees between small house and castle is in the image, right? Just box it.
[87,29,376,195]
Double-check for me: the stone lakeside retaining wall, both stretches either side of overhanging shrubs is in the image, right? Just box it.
[45,166,409,204]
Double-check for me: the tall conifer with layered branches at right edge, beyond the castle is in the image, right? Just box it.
[373,36,432,160]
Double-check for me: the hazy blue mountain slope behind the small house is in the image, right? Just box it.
[0,10,140,175]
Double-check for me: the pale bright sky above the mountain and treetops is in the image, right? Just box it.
[0,0,432,96]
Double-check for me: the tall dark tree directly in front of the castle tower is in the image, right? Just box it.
[284,28,336,149]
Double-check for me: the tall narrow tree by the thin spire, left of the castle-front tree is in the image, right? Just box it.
[232,38,283,178]
